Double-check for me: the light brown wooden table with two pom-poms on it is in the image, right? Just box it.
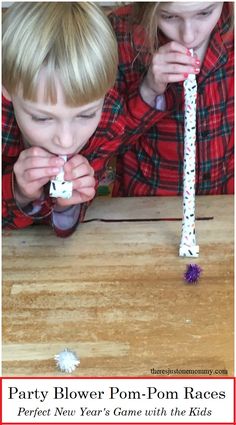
[3,196,234,376]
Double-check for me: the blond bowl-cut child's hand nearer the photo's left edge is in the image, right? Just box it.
[14,146,64,207]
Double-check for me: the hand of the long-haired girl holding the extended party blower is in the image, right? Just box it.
[140,41,200,104]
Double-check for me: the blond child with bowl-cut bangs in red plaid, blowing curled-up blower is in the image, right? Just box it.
[2,2,161,237]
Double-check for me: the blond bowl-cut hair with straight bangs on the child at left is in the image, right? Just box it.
[2,2,118,106]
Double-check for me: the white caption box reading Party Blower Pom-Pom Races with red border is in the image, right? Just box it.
[2,377,234,425]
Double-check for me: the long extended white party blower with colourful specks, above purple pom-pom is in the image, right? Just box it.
[179,49,199,257]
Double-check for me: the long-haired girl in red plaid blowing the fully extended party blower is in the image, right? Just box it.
[110,2,234,196]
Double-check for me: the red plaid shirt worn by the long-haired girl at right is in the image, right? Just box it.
[110,2,234,196]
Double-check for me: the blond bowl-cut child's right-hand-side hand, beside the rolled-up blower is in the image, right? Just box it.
[57,154,95,206]
